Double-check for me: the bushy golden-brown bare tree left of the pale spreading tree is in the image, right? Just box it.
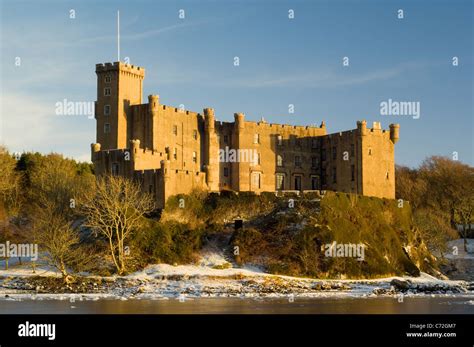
[29,154,94,282]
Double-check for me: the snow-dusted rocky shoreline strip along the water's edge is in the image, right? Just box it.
[0,264,474,300]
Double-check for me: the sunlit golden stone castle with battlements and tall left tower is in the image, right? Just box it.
[91,62,400,208]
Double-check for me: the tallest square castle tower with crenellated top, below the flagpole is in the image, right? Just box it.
[95,62,145,150]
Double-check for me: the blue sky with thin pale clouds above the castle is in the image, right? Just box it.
[0,0,474,166]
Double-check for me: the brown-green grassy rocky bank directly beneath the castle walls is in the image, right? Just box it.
[162,192,436,278]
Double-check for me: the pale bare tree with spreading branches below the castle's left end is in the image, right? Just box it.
[84,176,155,275]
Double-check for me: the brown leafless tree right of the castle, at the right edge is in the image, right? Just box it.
[402,156,474,254]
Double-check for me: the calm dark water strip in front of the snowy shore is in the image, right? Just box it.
[0,296,474,314]
